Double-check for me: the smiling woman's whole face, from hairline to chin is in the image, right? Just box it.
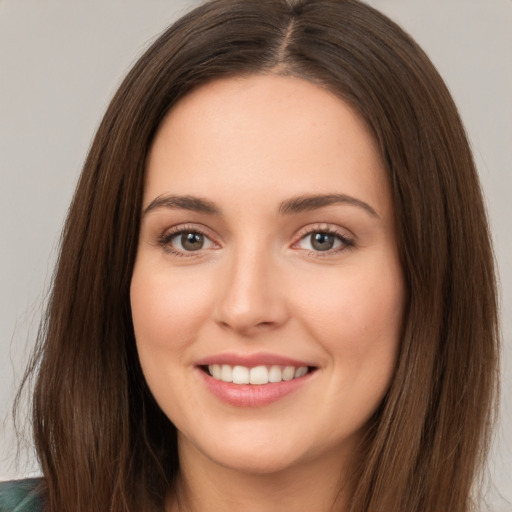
[131,75,404,473]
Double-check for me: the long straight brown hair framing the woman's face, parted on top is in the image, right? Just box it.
[17,0,498,512]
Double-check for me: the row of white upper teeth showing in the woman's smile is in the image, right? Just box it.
[208,364,308,385]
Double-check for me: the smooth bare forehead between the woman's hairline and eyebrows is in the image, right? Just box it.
[145,75,389,217]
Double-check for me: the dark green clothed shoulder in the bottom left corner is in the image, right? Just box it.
[0,478,42,512]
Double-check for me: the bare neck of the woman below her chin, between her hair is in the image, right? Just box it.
[166,436,353,512]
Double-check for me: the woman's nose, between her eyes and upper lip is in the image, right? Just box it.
[215,248,288,338]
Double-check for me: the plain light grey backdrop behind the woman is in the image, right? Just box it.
[0,0,512,511]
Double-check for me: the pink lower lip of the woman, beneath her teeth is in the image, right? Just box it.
[198,369,312,407]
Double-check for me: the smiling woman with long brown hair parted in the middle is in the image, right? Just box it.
[0,0,498,512]
